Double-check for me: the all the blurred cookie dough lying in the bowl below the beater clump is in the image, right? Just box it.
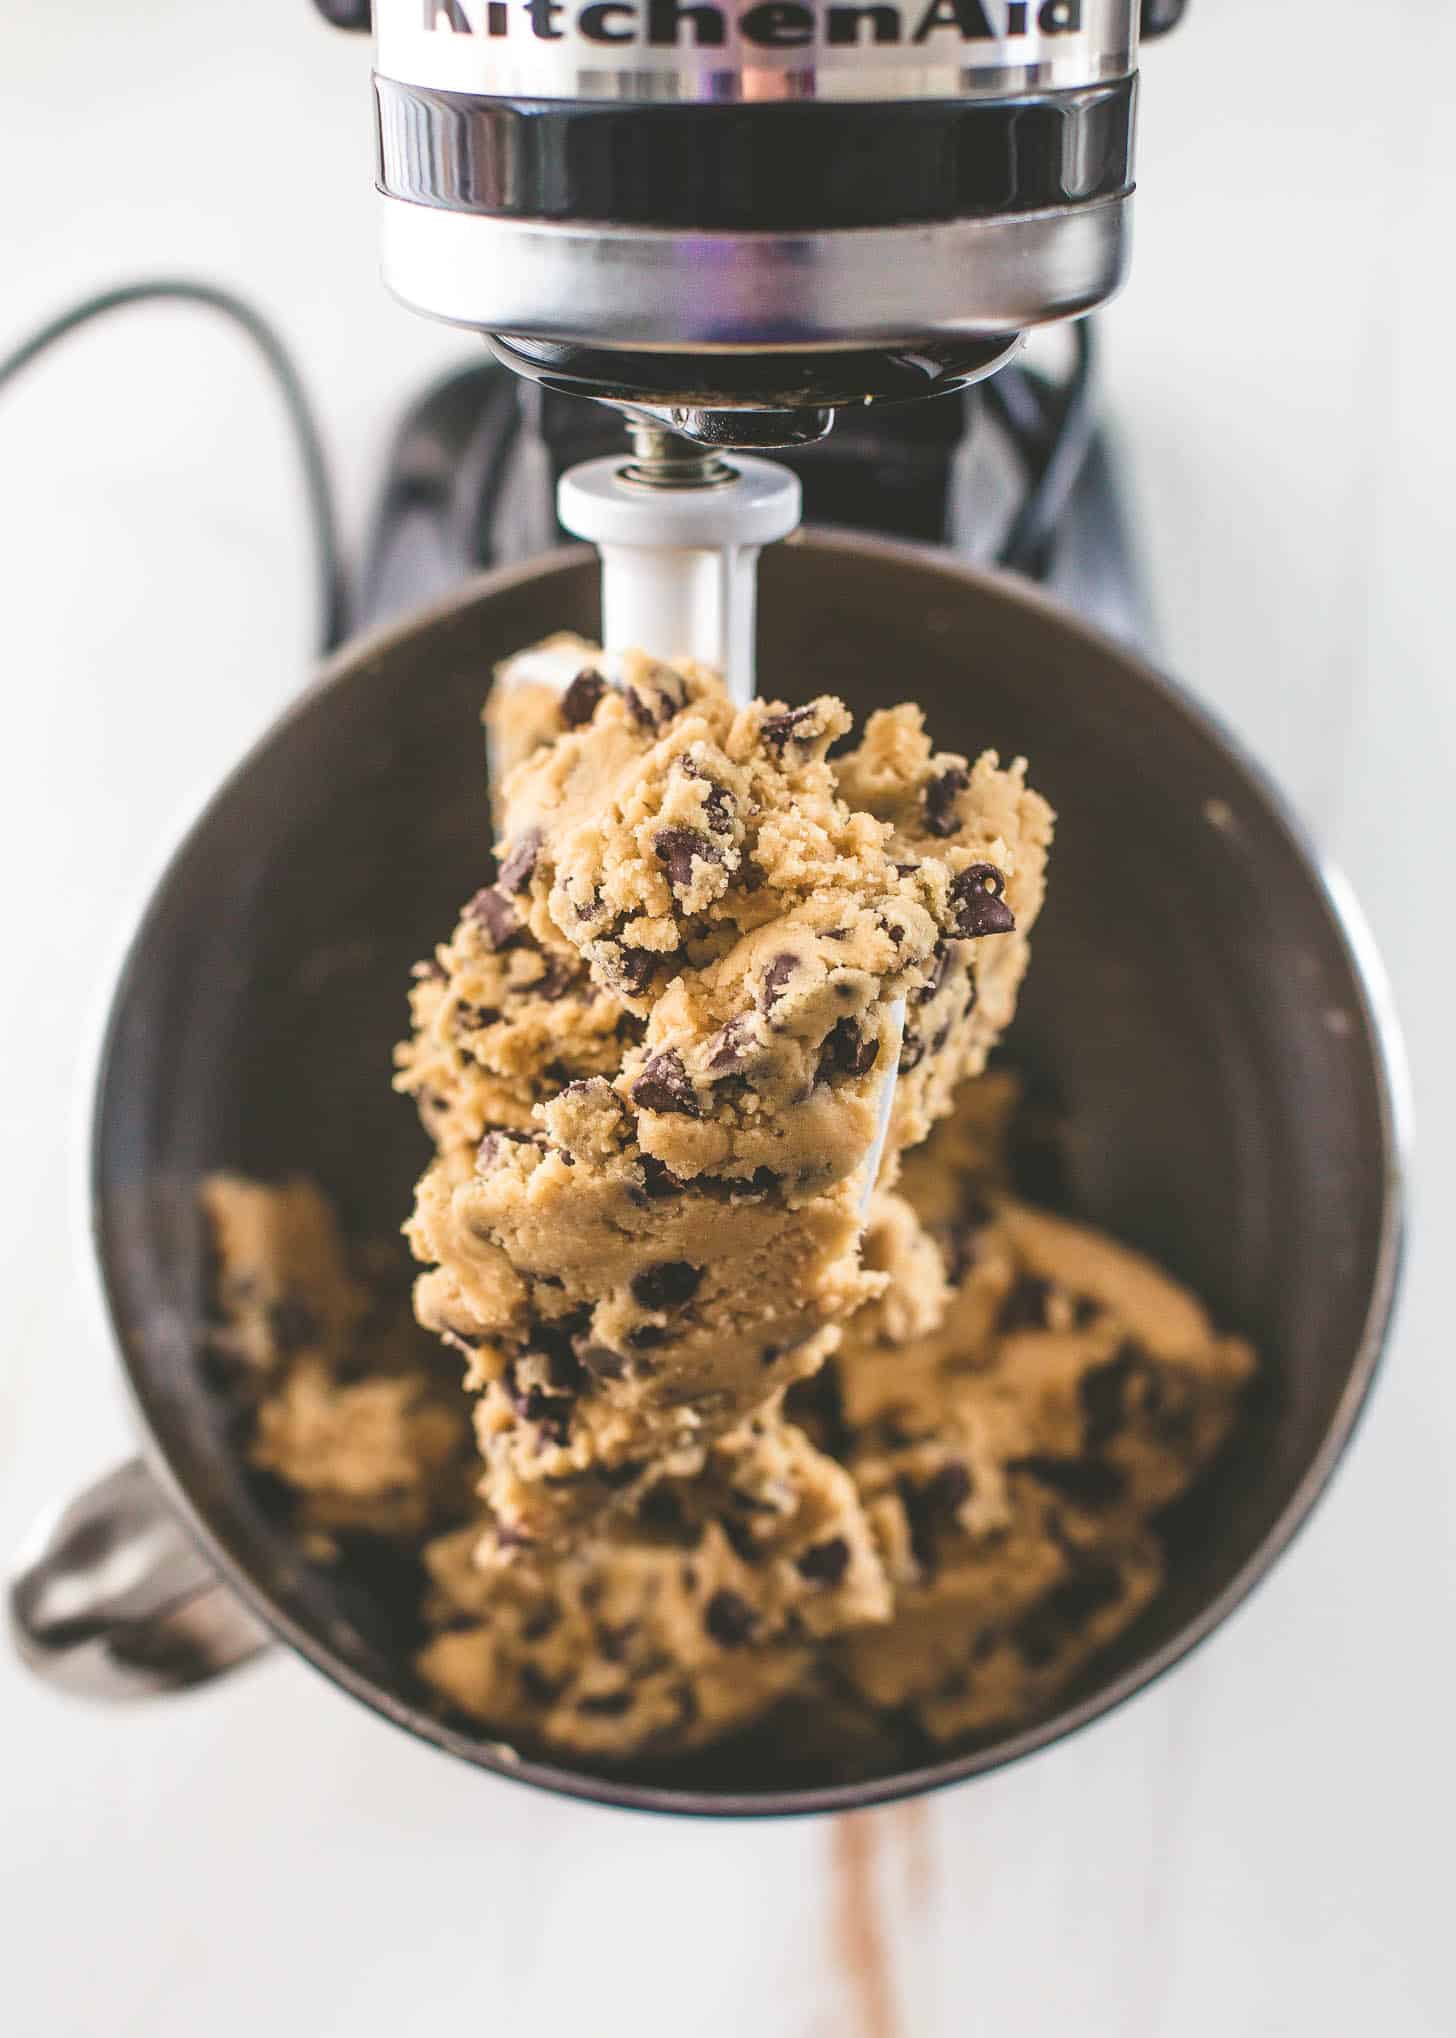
[208,1078,1254,1773]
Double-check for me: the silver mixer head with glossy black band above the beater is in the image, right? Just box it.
[326,0,1168,444]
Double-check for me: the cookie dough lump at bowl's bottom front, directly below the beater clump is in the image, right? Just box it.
[420,1416,891,1757]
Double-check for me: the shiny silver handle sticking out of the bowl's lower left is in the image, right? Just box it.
[8,1457,269,1700]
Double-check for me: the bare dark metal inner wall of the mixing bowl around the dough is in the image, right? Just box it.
[94,536,1401,1812]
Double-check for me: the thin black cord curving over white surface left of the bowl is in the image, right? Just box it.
[0,277,349,652]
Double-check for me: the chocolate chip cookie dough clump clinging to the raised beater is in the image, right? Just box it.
[400,642,1050,1561]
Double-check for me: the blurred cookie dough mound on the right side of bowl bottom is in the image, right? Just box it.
[803,1123,1254,1740]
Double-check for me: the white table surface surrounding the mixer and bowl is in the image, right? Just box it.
[0,0,1456,2038]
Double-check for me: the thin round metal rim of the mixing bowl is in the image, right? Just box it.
[90,526,1409,1818]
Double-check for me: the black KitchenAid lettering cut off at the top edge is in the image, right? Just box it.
[422,0,1083,55]
